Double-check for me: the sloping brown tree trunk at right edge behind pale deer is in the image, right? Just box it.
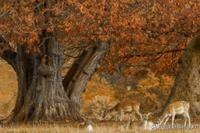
[163,36,200,115]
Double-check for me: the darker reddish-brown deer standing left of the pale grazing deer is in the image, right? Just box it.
[114,99,142,121]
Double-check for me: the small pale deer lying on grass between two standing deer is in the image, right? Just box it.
[141,112,155,130]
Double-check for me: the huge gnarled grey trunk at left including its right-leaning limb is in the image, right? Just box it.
[1,35,108,122]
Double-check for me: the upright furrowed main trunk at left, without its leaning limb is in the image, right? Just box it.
[3,38,81,122]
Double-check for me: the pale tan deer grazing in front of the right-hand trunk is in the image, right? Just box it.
[159,101,190,128]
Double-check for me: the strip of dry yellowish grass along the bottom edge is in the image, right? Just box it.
[0,124,200,133]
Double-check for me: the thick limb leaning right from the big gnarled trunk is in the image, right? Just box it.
[63,42,109,109]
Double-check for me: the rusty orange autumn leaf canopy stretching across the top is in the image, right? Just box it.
[0,0,200,75]
